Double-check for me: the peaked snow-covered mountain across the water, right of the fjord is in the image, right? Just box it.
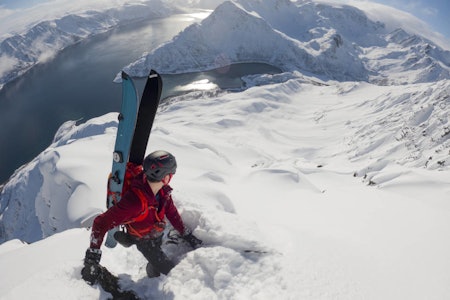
[125,0,450,85]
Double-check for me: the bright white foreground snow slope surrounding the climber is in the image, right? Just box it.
[0,72,450,299]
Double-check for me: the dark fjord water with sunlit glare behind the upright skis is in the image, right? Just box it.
[0,14,279,184]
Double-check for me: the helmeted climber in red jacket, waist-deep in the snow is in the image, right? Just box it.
[81,150,202,285]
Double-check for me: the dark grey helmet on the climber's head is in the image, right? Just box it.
[143,150,177,182]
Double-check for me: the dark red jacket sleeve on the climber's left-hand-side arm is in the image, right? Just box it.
[90,191,142,249]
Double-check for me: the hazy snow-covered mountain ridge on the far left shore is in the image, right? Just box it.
[0,0,180,89]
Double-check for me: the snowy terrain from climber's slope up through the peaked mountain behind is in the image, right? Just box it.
[0,0,450,300]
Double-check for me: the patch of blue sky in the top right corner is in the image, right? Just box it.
[372,0,450,41]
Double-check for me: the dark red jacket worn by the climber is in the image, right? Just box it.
[90,173,184,249]
